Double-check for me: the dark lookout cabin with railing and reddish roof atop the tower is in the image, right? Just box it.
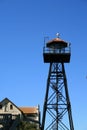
[43,38,71,63]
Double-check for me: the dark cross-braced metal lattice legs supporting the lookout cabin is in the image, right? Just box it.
[42,63,74,130]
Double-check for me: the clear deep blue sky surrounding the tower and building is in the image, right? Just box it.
[0,0,87,130]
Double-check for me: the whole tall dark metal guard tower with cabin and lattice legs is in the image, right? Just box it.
[42,34,74,130]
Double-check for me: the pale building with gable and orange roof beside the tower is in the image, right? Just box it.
[0,98,40,130]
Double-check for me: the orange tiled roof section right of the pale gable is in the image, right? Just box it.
[19,107,38,114]
